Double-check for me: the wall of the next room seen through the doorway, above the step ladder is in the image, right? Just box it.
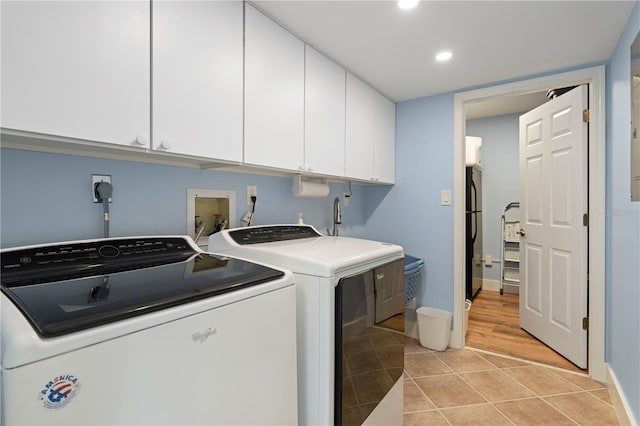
[467,114,520,281]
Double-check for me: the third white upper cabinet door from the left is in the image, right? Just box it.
[244,4,304,170]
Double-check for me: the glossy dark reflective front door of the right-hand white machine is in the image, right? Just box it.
[334,259,404,425]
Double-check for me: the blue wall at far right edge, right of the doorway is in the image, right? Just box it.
[606,3,640,420]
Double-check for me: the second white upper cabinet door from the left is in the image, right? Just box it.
[152,1,243,161]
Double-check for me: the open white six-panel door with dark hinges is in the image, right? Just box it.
[520,86,588,368]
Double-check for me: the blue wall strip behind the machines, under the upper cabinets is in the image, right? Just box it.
[0,149,364,247]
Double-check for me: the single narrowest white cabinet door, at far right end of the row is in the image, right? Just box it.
[373,93,396,183]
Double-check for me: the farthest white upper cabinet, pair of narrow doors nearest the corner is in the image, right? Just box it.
[345,72,395,183]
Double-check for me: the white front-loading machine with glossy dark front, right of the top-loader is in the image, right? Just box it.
[208,225,404,425]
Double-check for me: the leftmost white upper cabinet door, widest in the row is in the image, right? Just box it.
[1,1,150,146]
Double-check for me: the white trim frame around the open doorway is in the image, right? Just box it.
[450,65,607,383]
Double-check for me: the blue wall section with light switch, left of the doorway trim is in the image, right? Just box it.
[365,94,453,310]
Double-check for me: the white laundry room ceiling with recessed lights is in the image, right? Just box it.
[252,0,638,112]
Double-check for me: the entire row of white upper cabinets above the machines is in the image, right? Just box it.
[0,0,395,183]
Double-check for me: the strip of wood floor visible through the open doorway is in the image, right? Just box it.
[466,290,585,372]
